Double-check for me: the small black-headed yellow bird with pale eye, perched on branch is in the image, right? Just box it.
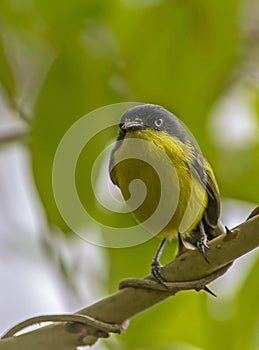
[109,104,224,283]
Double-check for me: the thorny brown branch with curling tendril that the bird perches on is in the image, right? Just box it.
[0,207,259,350]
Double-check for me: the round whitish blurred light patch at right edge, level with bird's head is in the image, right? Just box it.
[208,86,259,150]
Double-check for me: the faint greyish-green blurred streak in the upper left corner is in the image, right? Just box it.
[1,19,56,119]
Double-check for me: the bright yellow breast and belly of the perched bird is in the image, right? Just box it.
[111,129,207,238]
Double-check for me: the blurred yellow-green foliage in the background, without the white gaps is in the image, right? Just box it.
[0,0,259,350]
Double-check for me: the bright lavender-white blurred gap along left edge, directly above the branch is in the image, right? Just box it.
[0,146,64,333]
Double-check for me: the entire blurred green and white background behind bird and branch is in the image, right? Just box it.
[0,0,259,350]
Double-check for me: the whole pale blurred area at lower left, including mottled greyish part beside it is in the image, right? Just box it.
[0,144,108,350]
